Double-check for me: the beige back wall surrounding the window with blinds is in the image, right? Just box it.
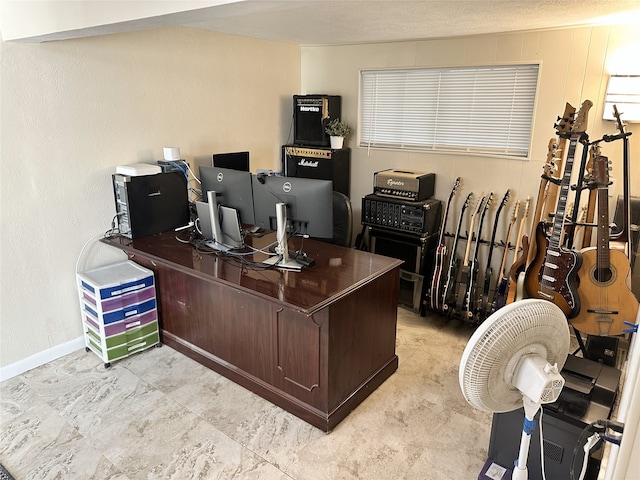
[302,23,640,244]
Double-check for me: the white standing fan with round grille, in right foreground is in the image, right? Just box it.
[459,299,570,480]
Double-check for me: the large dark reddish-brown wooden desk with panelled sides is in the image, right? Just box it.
[102,233,401,431]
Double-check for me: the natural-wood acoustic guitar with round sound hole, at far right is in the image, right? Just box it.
[570,156,638,335]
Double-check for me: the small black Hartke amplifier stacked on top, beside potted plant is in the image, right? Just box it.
[293,95,342,147]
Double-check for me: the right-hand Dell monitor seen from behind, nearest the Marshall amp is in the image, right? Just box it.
[253,175,333,238]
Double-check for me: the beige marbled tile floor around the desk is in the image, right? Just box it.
[0,308,491,480]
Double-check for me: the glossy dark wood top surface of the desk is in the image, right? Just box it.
[102,232,402,314]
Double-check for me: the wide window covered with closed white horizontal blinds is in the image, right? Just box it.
[359,65,539,158]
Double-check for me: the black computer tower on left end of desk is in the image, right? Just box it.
[113,172,190,238]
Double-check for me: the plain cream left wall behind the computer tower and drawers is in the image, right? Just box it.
[0,28,300,367]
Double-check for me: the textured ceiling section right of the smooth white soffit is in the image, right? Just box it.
[174,0,640,45]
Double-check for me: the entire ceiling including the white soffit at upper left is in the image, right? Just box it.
[7,0,640,45]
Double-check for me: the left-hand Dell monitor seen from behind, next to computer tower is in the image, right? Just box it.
[200,165,255,225]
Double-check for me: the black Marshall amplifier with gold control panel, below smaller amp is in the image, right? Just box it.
[282,145,351,197]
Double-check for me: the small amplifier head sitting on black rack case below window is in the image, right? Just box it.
[373,170,436,202]
